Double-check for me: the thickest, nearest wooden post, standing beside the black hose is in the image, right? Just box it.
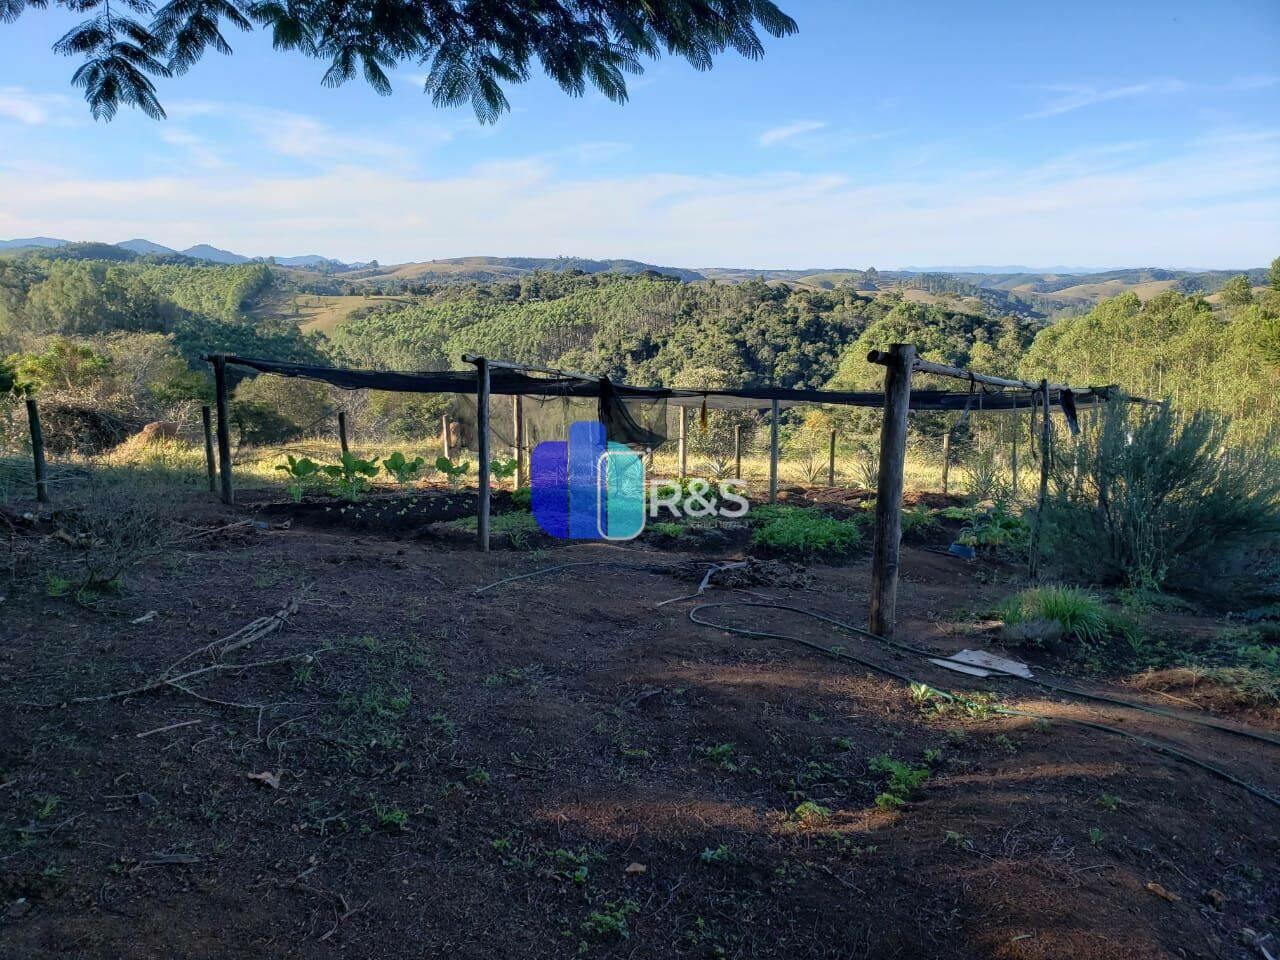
[868,343,915,636]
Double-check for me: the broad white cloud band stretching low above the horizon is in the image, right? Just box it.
[0,131,1280,268]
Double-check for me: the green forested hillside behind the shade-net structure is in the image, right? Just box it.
[0,248,1280,450]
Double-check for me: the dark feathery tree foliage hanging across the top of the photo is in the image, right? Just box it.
[0,0,796,122]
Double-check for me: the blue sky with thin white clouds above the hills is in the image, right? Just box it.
[0,0,1280,269]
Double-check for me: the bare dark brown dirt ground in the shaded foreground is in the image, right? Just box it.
[0,496,1280,960]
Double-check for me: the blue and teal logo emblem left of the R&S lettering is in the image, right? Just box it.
[529,420,645,540]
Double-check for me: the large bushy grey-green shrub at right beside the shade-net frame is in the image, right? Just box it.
[1044,403,1280,589]
